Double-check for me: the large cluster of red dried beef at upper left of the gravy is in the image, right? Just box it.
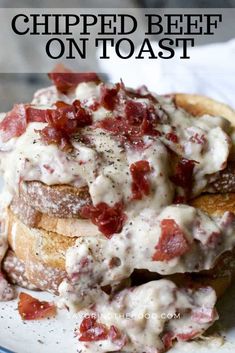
[0,100,92,150]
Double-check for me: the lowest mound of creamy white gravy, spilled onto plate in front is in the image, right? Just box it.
[75,280,217,353]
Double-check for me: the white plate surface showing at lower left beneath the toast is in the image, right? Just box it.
[0,289,77,353]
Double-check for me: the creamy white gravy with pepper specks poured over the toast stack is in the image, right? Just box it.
[0,83,235,353]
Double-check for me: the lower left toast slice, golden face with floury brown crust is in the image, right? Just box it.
[8,211,76,293]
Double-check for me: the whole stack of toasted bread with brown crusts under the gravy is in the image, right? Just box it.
[3,94,235,295]
